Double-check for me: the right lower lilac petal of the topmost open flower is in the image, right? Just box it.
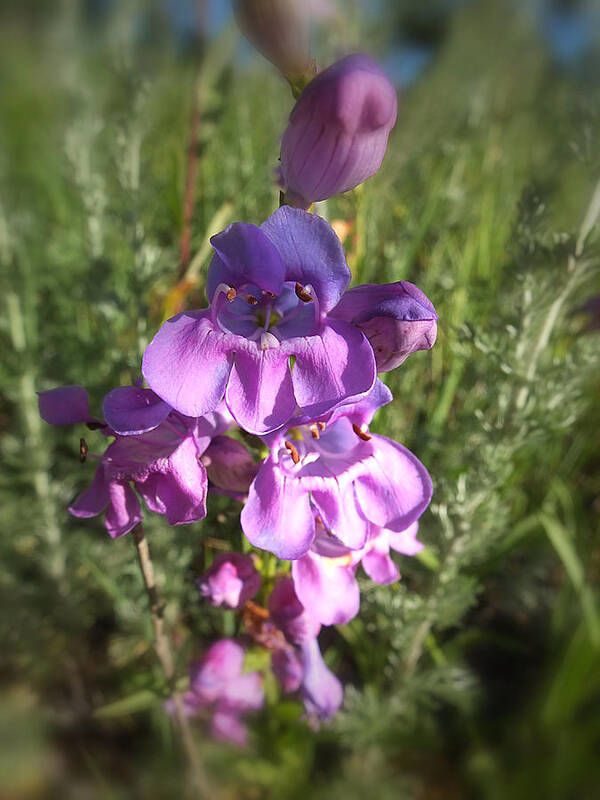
[286,320,377,416]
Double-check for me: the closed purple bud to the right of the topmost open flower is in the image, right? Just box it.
[332,281,438,372]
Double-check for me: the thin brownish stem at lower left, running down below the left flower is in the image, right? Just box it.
[132,523,213,798]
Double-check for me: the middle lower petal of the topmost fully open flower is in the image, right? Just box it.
[225,348,296,435]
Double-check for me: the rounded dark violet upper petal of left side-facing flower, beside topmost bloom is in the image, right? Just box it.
[102,386,171,436]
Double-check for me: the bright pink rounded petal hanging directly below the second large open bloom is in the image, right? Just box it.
[292,552,360,625]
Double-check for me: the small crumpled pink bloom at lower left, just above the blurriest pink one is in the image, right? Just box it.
[196,553,260,608]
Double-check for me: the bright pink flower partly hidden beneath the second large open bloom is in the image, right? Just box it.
[292,522,423,625]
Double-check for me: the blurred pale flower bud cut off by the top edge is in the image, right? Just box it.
[233,0,310,79]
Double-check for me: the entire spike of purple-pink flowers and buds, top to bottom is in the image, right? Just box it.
[39,0,437,744]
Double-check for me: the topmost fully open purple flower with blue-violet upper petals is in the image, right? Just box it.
[143,207,375,434]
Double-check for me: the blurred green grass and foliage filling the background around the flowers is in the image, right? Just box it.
[0,2,600,800]
